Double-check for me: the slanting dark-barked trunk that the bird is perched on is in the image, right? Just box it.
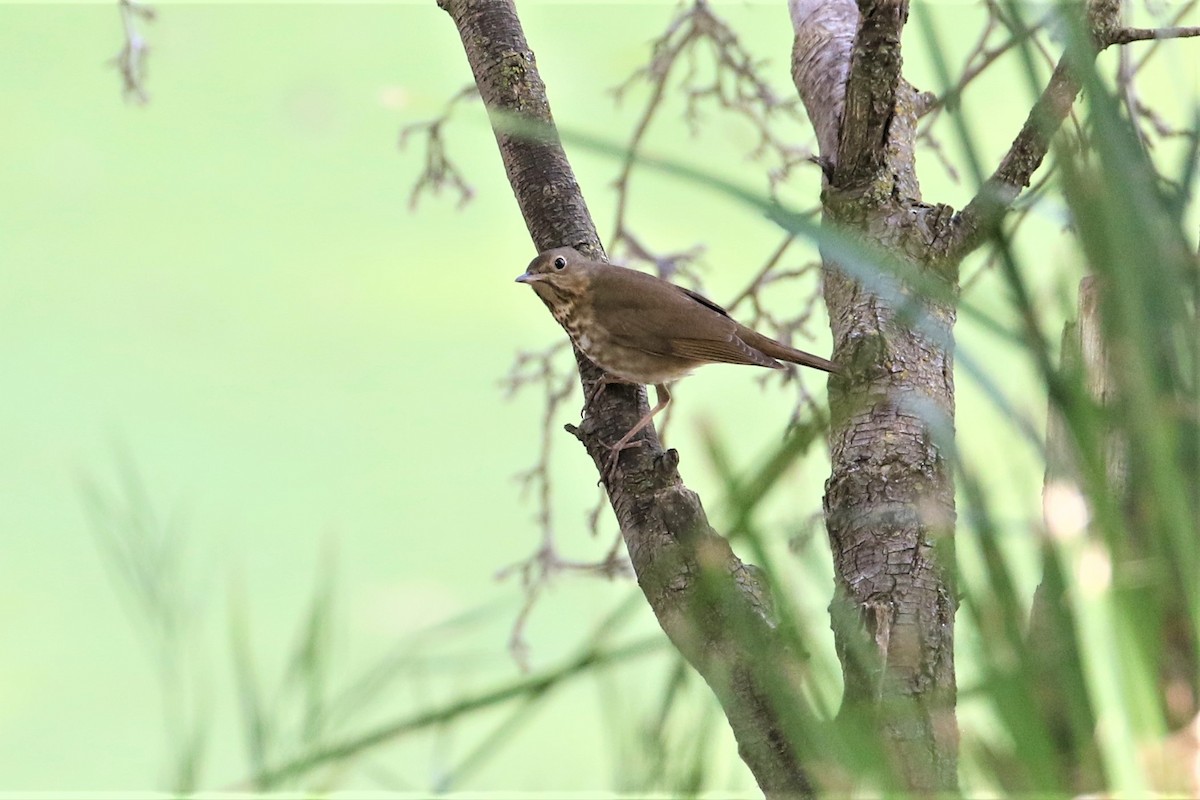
[439,0,811,798]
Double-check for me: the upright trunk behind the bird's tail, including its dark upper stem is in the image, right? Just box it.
[793,0,958,792]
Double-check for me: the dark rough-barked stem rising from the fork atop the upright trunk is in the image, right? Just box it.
[830,0,908,190]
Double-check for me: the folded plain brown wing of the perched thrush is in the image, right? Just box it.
[592,266,782,368]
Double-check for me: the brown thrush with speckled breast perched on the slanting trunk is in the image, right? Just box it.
[517,247,838,469]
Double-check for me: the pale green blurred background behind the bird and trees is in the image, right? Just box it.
[0,0,1196,792]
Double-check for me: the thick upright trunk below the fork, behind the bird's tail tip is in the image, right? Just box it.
[824,196,958,790]
